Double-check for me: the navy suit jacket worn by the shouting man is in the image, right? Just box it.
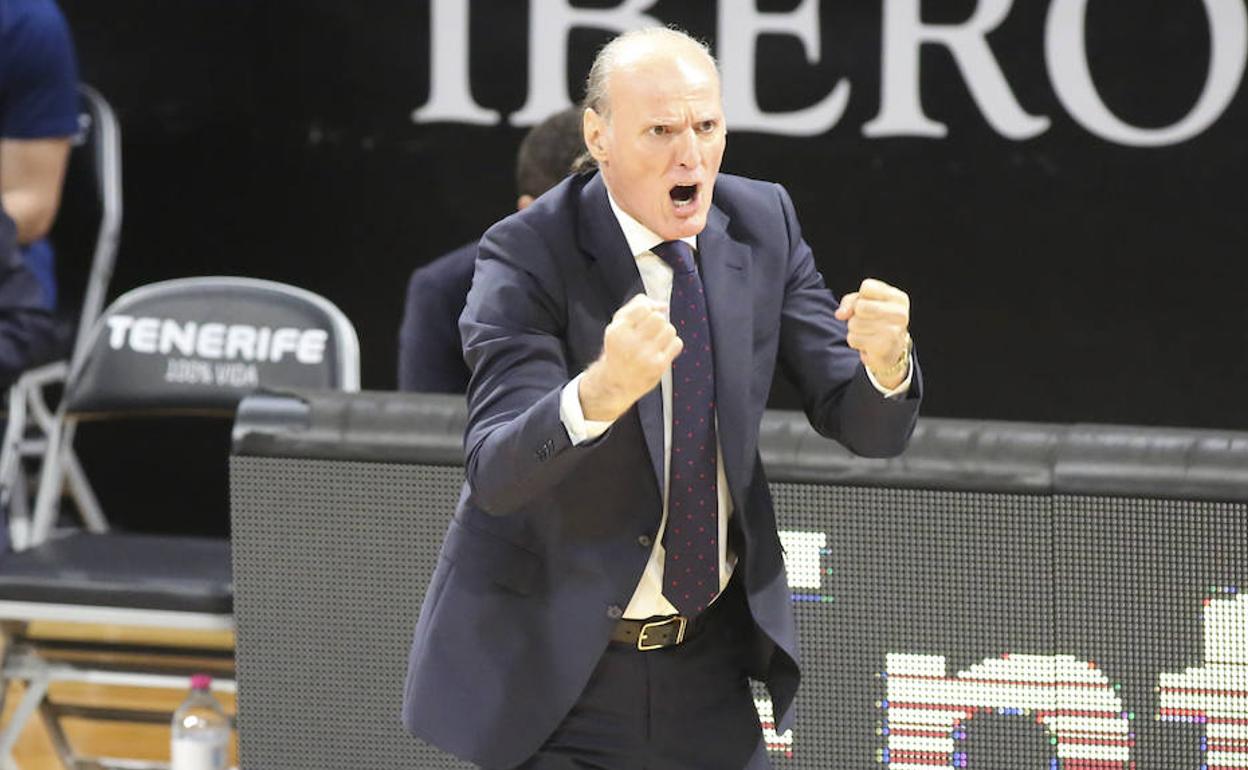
[403,175,922,768]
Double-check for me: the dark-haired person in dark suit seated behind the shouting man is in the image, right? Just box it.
[398,109,584,393]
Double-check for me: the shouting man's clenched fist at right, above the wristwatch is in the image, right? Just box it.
[836,278,910,389]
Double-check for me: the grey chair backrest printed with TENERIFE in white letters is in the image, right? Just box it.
[64,276,359,416]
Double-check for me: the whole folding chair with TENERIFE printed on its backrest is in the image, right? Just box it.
[0,277,359,770]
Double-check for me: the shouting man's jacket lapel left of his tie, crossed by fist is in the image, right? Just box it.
[578,175,663,489]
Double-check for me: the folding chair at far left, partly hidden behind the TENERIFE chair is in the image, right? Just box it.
[0,84,121,550]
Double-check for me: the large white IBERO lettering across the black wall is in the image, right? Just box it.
[414,0,1248,144]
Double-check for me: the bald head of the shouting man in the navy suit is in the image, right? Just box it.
[583,27,725,241]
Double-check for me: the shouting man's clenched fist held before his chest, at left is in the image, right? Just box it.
[579,295,684,422]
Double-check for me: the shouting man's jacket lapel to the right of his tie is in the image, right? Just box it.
[698,206,754,510]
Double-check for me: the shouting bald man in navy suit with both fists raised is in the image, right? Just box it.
[403,29,922,770]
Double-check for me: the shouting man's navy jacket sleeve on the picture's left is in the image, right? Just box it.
[459,217,611,515]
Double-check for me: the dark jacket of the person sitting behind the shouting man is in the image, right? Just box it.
[398,241,477,393]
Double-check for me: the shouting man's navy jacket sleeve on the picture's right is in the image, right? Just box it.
[776,185,922,457]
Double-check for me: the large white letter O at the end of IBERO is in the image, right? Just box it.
[1045,0,1248,147]
